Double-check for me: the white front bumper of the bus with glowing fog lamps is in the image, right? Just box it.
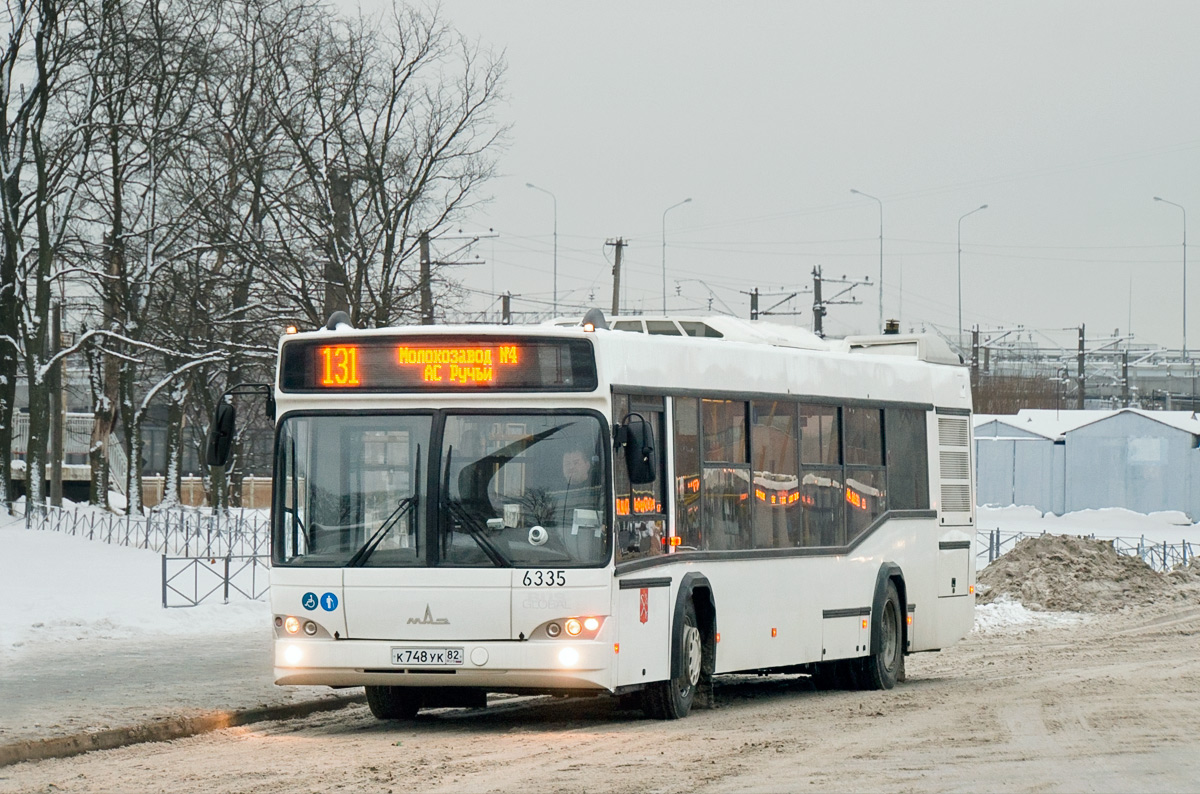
[275,637,617,691]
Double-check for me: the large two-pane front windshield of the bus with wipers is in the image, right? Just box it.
[272,414,611,567]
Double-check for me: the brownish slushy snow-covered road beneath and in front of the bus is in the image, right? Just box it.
[0,603,1200,794]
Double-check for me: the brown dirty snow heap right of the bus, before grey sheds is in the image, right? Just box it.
[978,535,1187,612]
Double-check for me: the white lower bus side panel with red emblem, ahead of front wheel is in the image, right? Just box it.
[617,577,671,686]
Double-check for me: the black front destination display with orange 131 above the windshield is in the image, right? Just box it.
[280,336,596,392]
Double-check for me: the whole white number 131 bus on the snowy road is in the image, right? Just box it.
[225,312,974,718]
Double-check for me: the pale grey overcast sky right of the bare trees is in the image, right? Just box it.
[427,0,1200,348]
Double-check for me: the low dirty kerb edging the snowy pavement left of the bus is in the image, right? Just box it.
[0,694,366,766]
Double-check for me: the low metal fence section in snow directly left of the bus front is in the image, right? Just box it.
[162,554,271,609]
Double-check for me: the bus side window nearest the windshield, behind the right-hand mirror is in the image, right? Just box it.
[612,395,667,563]
